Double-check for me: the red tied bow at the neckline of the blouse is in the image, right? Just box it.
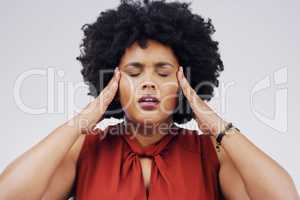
[121,124,180,199]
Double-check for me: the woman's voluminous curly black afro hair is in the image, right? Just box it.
[76,0,224,124]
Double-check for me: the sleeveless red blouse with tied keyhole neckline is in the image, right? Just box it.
[73,123,225,200]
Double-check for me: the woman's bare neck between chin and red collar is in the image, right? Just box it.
[125,118,173,147]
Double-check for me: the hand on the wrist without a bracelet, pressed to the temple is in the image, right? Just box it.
[71,67,121,134]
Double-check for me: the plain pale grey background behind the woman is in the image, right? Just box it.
[0,0,300,194]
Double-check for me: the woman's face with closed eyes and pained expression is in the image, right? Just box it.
[119,40,179,124]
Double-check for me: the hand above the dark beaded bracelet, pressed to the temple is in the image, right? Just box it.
[177,67,228,135]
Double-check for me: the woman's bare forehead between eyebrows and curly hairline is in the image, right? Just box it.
[120,40,178,66]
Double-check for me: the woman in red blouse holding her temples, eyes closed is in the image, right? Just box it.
[0,1,299,200]
